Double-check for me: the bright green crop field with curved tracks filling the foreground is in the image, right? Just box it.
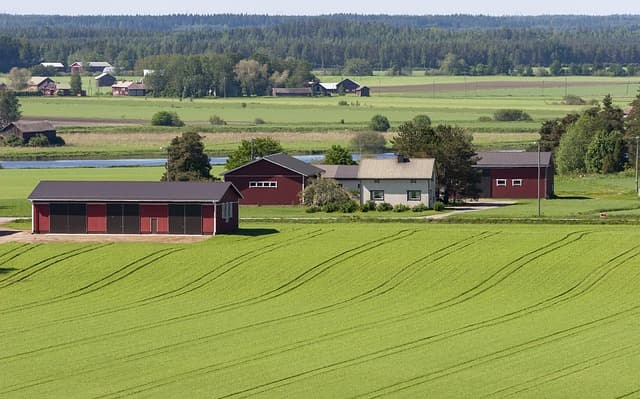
[0,224,640,398]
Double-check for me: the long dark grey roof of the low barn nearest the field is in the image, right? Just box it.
[28,181,242,202]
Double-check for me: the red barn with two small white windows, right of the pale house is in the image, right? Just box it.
[475,151,554,198]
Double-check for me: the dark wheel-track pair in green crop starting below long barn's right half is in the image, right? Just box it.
[0,248,183,314]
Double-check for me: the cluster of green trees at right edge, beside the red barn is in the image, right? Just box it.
[540,94,640,174]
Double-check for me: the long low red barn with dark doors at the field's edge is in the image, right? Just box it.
[29,181,242,235]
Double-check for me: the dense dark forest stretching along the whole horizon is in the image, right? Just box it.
[0,14,640,75]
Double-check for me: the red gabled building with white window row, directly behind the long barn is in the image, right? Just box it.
[222,153,323,205]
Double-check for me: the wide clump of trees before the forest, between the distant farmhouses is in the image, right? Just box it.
[136,53,313,98]
